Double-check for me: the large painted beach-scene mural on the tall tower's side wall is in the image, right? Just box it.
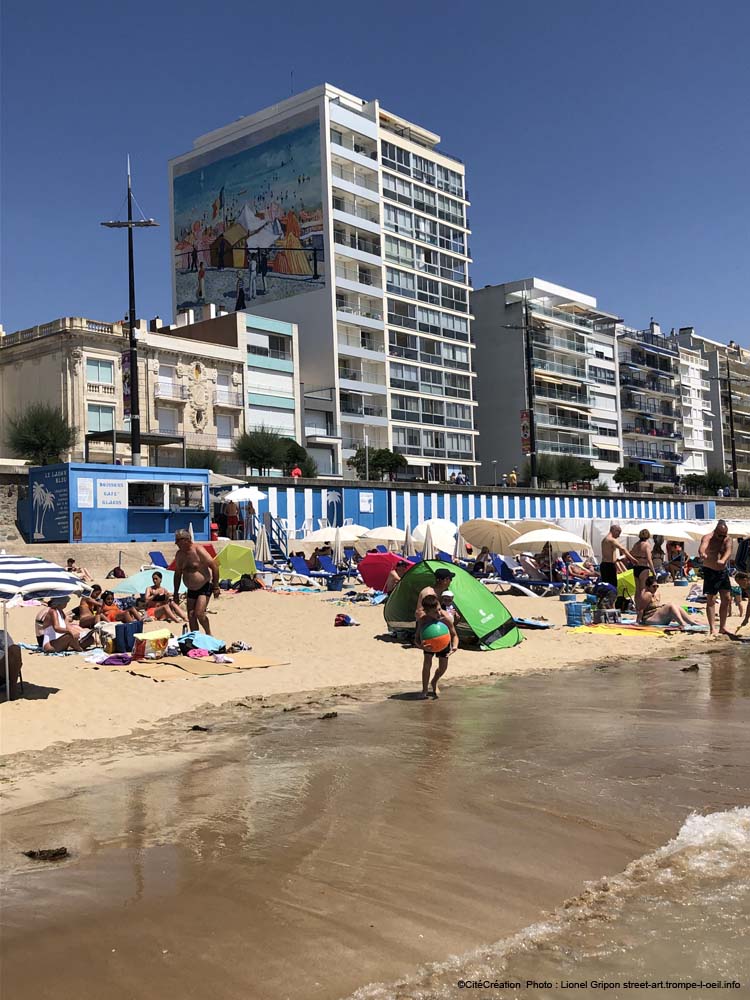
[173,121,325,312]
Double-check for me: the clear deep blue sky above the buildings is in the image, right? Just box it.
[0,0,750,345]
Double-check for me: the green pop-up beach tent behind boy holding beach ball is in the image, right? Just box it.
[383,560,521,649]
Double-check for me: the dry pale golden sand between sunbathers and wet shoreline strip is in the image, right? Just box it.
[0,555,720,754]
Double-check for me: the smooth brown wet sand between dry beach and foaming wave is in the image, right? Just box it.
[3,647,750,1000]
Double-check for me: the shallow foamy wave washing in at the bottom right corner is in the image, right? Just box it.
[350,807,750,1000]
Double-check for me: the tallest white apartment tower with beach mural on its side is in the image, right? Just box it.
[169,84,477,479]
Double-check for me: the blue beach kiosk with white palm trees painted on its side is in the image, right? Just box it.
[28,463,210,542]
